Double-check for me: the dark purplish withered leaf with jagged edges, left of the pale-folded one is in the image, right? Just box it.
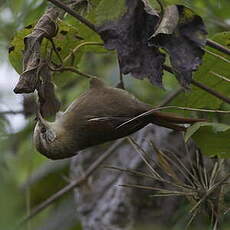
[98,0,165,86]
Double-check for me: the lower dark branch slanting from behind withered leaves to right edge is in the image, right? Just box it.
[163,65,230,104]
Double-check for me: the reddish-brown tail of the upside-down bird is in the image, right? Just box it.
[119,109,205,131]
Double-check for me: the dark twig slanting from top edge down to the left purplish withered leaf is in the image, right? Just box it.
[48,0,98,33]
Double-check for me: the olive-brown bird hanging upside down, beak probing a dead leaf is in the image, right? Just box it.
[33,77,203,160]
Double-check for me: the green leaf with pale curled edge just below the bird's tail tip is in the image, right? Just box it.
[185,122,230,158]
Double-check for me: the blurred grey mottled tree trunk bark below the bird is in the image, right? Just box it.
[71,125,195,230]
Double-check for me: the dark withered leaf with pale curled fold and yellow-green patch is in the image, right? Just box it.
[149,5,207,88]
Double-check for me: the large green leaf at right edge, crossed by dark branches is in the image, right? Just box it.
[174,32,230,109]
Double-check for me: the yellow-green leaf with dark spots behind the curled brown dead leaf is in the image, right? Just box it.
[9,21,93,85]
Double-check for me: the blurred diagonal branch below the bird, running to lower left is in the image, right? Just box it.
[16,139,125,229]
